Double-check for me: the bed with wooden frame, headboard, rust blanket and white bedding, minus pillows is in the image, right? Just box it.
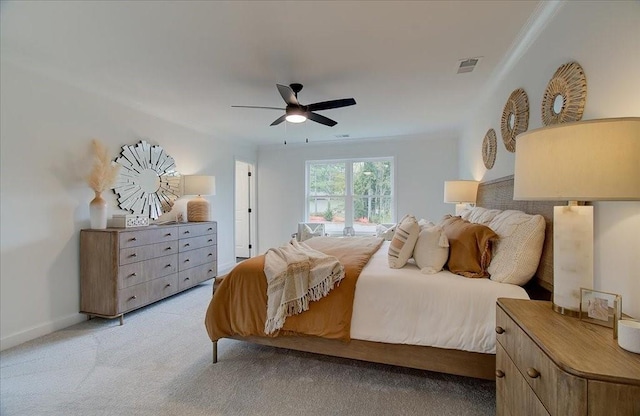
[205,176,557,379]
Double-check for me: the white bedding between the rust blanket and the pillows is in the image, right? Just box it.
[351,241,529,354]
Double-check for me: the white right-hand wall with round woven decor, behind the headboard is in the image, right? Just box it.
[460,1,640,318]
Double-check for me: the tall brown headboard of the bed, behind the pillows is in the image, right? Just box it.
[476,175,566,299]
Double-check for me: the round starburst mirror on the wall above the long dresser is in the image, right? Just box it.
[113,140,180,220]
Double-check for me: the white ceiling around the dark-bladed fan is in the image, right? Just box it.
[0,0,542,144]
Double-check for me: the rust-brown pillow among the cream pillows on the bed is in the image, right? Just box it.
[439,215,498,277]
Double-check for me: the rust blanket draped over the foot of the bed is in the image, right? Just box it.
[205,237,382,341]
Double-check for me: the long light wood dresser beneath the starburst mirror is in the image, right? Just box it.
[80,222,217,325]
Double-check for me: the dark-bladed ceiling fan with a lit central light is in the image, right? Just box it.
[231,83,356,127]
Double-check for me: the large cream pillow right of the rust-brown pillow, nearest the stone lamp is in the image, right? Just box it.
[487,210,545,286]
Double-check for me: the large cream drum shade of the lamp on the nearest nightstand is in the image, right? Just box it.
[513,117,640,201]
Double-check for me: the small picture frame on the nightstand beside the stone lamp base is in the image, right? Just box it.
[580,288,622,338]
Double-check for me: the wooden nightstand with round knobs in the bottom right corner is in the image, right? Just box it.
[496,298,640,416]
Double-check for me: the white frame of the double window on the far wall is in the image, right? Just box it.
[304,156,396,236]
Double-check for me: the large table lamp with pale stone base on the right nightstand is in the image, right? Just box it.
[513,117,640,316]
